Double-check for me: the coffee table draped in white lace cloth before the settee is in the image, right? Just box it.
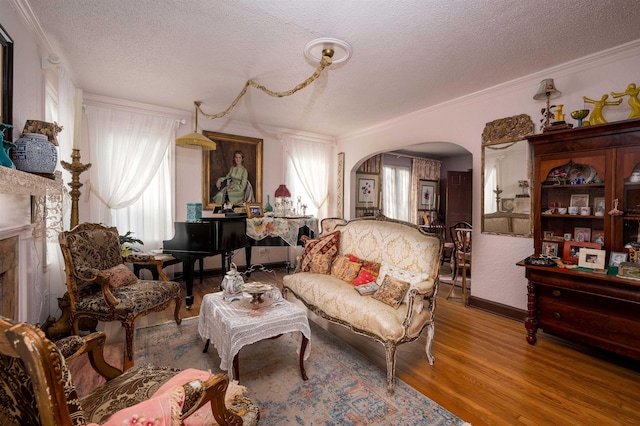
[198,292,311,380]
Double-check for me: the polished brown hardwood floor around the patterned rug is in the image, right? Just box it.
[131,269,640,426]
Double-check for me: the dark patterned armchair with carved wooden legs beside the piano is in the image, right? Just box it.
[58,223,182,370]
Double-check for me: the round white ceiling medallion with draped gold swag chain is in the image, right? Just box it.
[196,38,352,119]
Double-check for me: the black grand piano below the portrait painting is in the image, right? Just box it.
[162,215,251,308]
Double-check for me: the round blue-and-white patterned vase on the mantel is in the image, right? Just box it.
[11,133,58,174]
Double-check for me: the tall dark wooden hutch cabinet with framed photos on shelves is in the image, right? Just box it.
[525,120,640,359]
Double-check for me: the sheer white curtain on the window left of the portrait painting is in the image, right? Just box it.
[85,105,179,250]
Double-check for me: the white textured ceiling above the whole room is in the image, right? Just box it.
[20,0,640,136]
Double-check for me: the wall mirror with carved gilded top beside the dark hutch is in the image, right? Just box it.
[482,114,535,237]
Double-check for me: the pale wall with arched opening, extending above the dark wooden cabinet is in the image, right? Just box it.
[338,40,640,309]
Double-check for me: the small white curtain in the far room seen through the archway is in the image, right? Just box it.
[382,166,411,221]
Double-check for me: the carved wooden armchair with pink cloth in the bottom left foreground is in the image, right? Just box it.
[0,316,260,426]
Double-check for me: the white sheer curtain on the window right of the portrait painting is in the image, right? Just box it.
[283,137,333,219]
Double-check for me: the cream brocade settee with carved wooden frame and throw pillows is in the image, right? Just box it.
[283,215,443,394]
